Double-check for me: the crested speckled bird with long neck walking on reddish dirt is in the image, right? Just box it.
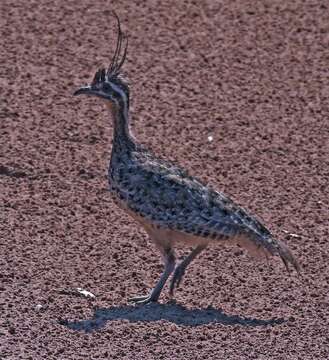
[74,13,300,304]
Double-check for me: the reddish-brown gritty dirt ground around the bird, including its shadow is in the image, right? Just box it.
[0,0,329,360]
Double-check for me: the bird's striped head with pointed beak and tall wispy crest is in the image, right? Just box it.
[74,14,129,108]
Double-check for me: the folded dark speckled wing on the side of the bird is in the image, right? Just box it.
[125,153,264,236]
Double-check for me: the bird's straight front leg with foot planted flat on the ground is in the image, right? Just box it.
[129,248,175,304]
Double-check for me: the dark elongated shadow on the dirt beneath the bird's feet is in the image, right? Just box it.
[59,303,284,332]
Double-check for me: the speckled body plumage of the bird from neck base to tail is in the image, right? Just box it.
[109,126,295,264]
